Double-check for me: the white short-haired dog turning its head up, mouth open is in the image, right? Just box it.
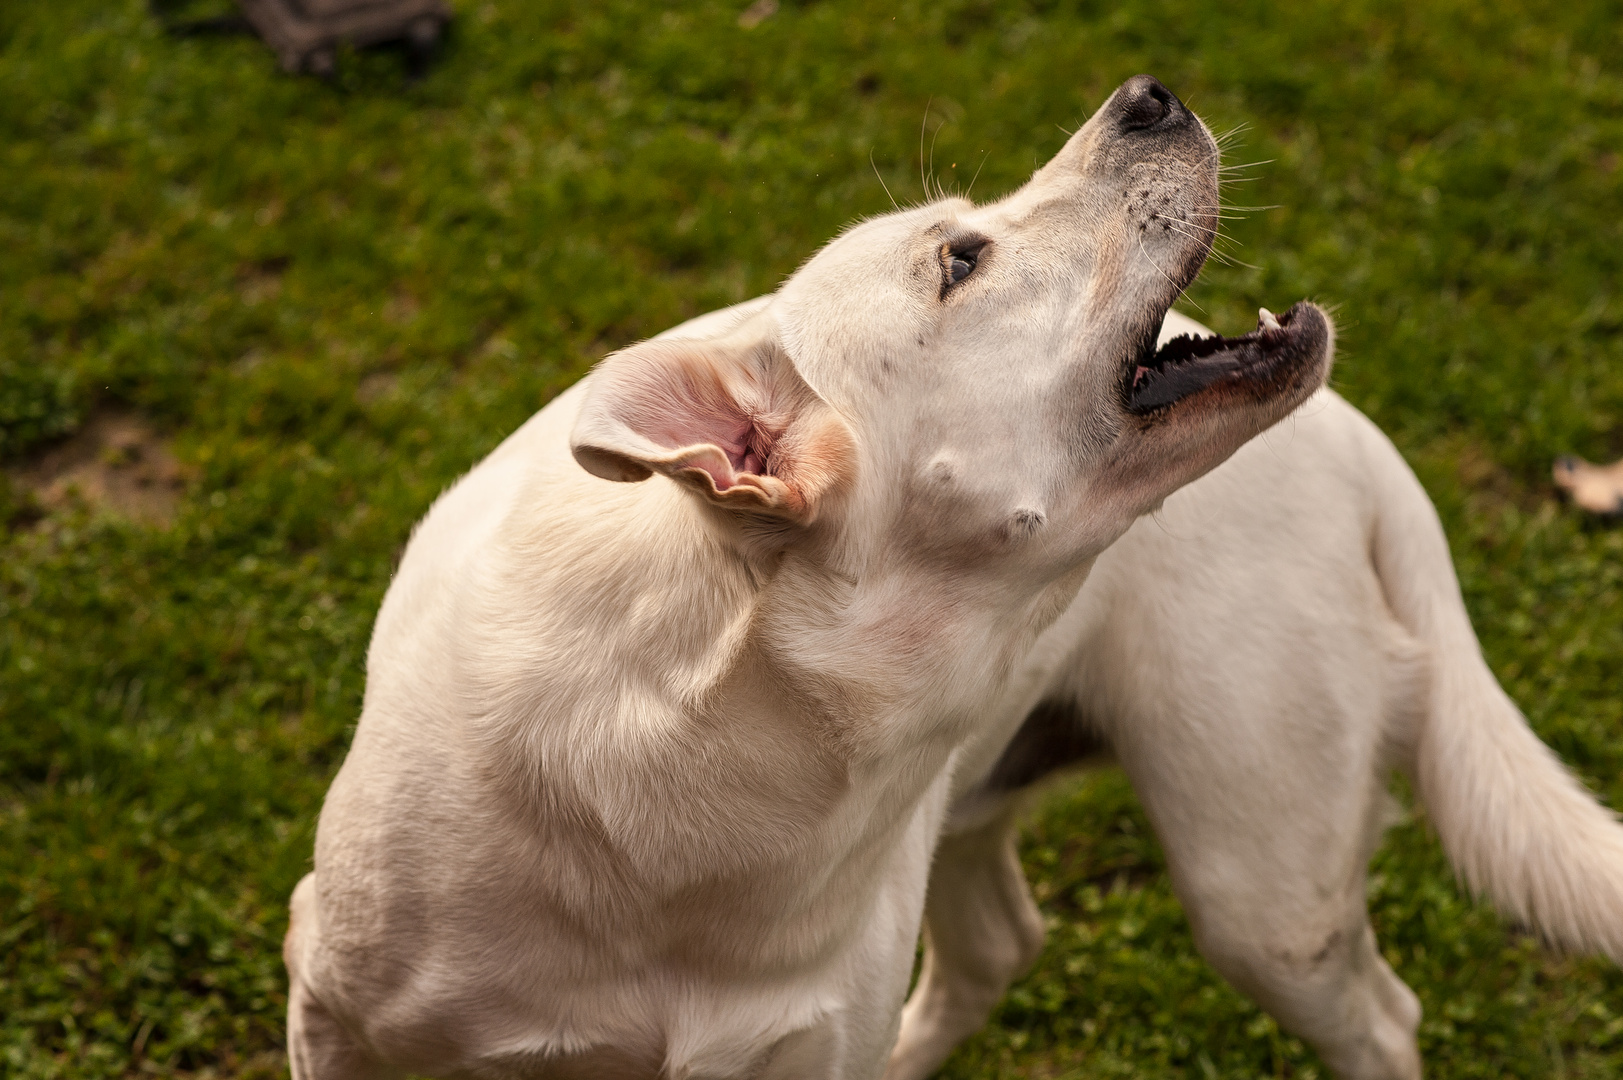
[286,76,1623,1080]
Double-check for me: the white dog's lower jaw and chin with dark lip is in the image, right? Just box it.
[1121,300,1331,421]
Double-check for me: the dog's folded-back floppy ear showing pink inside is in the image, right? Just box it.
[570,320,855,525]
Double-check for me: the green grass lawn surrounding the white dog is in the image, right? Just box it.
[0,0,1623,1080]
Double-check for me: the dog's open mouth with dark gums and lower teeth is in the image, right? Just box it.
[1123,302,1329,416]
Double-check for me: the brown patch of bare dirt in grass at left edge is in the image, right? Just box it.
[8,411,187,526]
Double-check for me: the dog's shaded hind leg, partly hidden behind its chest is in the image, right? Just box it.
[885,796,1044,1080]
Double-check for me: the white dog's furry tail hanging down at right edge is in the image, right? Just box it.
[1373,437,1623,963]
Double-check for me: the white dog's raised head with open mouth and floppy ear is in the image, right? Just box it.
[573,75,1332,578]
